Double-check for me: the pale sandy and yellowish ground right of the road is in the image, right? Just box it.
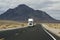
[42,23,60,37]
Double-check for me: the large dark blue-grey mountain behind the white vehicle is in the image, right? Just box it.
[0,4,58,22]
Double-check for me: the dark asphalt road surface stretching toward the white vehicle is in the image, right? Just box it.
[0,25,53,40]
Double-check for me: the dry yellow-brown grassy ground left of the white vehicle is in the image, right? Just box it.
[0,20,27,29]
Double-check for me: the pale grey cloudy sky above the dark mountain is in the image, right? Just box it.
[0,0,60,20]
